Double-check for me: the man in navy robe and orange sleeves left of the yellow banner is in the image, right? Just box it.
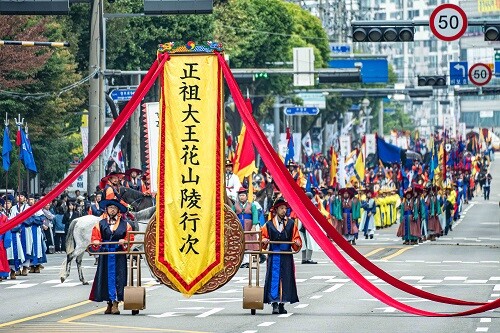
[89,199,134,314]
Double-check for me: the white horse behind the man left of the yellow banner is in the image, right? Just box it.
[59,188,156,285]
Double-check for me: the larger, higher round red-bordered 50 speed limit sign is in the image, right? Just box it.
[429,3,467,42]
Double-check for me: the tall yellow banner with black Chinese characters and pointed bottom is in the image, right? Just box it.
[155,54,225,295]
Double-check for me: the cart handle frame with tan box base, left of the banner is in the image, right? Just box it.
[87,231,146,315]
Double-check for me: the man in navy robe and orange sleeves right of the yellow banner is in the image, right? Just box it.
[262,198,302,314]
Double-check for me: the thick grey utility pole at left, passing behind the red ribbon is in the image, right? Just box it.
[87,0,101,194]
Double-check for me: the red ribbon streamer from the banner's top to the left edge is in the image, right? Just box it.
[0,54,170,234]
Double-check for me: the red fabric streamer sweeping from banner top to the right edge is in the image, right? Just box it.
[218,54,500,317]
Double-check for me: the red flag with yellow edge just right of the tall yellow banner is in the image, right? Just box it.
[233,99,257,182]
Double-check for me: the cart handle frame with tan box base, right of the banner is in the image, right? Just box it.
[243,231,299,315]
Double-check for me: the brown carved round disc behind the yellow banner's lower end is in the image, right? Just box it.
[144,205,245,294]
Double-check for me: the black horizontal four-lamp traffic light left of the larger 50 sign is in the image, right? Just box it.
[351,23,415,42]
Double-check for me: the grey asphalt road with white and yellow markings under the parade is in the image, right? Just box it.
[0,154,500,333]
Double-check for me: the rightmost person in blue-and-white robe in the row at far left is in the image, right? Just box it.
[28,194,47,273]
